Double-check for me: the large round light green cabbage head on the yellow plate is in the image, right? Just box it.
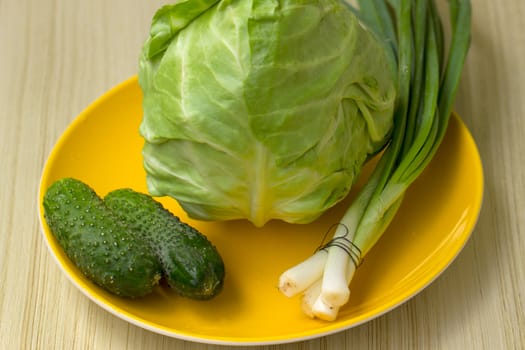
[139,0,395,226]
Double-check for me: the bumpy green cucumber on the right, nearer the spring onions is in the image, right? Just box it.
[104,189,225,300]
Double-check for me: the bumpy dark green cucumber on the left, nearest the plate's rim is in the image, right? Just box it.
[43,178,161,297]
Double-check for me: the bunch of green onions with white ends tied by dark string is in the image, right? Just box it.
[279,0,471,321]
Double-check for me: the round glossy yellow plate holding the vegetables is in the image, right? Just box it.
[39,78,483,345]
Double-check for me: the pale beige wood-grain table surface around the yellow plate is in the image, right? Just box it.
[0,0,525,350]
